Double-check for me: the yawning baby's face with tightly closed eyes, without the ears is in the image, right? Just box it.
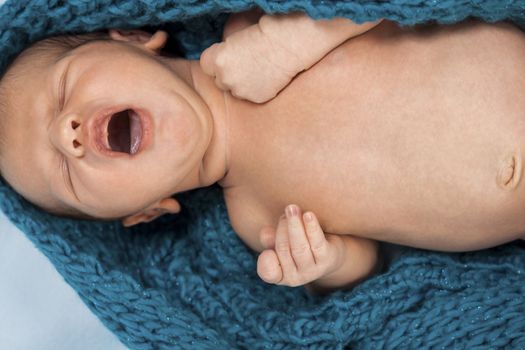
[1,33,211,218]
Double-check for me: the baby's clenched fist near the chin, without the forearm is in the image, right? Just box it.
[200,24,304,103]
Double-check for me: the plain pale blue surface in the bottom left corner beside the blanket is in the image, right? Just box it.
[0,0,126,350]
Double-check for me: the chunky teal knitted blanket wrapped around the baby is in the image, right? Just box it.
[0,0,525,349]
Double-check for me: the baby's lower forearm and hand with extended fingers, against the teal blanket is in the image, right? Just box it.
[257,206,378,293]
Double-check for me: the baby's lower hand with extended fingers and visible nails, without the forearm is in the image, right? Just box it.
[257,205,345,287]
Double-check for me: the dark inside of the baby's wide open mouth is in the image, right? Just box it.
[108,109,142,154]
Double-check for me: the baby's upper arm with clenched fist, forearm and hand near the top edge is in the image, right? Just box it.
[200,11,380,103]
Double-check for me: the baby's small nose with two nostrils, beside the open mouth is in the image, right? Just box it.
[50,114,85,157]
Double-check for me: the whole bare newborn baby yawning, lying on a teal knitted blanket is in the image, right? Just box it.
[0,11,525,291]
